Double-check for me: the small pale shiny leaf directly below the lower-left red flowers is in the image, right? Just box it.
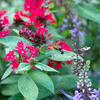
[15,63,31,74]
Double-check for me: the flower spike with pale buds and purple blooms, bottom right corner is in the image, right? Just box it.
[59,60,100,100]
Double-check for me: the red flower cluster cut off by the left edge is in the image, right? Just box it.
[0,10,11,38]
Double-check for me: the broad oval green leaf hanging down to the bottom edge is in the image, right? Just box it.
[18,75,38,100]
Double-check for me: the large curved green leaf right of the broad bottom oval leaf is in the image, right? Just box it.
[29,71,54,93]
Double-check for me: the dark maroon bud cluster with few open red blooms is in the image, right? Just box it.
[19,26,53,46]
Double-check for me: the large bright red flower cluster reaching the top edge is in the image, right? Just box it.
[24,0,56,28]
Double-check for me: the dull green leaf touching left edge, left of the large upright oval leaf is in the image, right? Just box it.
[0,75,20,84]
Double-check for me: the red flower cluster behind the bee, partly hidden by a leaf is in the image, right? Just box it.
[47,41,72,69]
